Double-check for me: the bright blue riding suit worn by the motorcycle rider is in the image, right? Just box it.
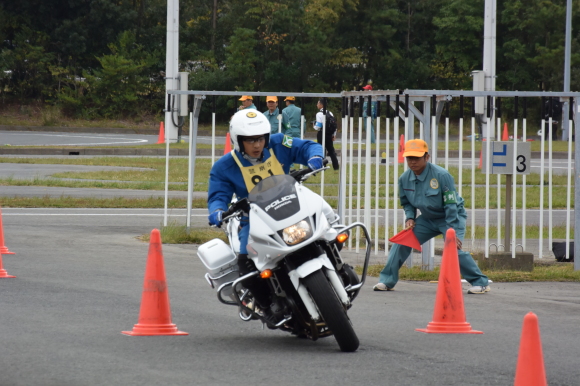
[207,134,322,254]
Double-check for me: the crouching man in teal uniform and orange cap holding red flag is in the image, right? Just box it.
[373,139,490,294]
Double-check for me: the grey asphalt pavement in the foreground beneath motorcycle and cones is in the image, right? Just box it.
[0,127,580,386]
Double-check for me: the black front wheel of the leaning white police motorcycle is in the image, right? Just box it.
[303,271,359,352]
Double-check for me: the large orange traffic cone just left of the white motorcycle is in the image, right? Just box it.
[122,229,188,336]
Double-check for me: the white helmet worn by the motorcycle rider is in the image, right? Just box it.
[230,109,271,153]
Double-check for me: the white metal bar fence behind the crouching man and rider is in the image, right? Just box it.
[169,90,580,270]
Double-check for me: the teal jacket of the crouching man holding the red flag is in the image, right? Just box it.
[399,162,467,230]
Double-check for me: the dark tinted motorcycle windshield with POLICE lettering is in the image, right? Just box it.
[248,174,300,220]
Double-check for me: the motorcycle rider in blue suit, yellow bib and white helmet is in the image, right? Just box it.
[208,110,323,310]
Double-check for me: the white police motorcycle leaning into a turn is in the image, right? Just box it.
[198,169,371,352]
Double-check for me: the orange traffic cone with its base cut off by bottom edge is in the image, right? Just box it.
[514,312,548,386]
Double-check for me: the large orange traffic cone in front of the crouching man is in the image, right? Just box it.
[416,228,483,334]
